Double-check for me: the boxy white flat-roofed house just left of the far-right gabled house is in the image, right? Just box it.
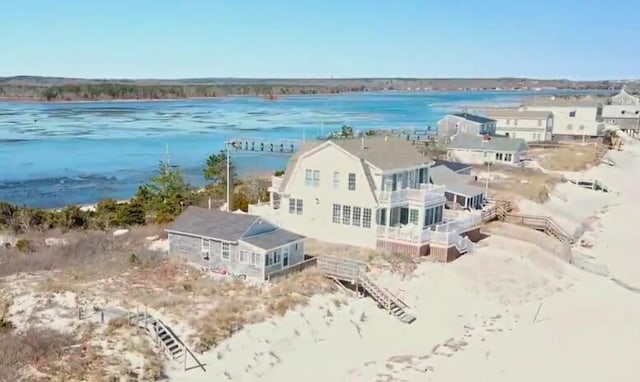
[523,96,605,141]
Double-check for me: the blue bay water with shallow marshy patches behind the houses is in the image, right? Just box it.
[0,92,568,208]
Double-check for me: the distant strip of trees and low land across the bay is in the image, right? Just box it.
[0,76,640,101]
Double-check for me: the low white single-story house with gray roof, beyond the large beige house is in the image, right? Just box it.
[447,134,528,166]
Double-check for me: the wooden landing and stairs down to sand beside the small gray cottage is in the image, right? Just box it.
[317,256,416,324]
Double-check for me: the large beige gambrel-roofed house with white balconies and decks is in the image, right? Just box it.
[249,137,481,259]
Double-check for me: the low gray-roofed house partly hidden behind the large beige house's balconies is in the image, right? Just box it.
[429,165,486,210]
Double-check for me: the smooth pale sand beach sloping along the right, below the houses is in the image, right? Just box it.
[158,133,640,382]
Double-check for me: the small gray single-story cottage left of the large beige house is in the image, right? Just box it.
[166,206,304,281]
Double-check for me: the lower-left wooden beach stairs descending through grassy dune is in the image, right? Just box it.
[129,313,206,371]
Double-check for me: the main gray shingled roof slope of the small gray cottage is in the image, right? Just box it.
[167,206,261,241]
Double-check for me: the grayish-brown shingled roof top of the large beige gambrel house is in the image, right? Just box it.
[331,136,433,171]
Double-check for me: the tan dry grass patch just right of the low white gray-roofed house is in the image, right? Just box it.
[529,143,599,171]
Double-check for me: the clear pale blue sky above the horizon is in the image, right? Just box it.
[0,0,640,79]
